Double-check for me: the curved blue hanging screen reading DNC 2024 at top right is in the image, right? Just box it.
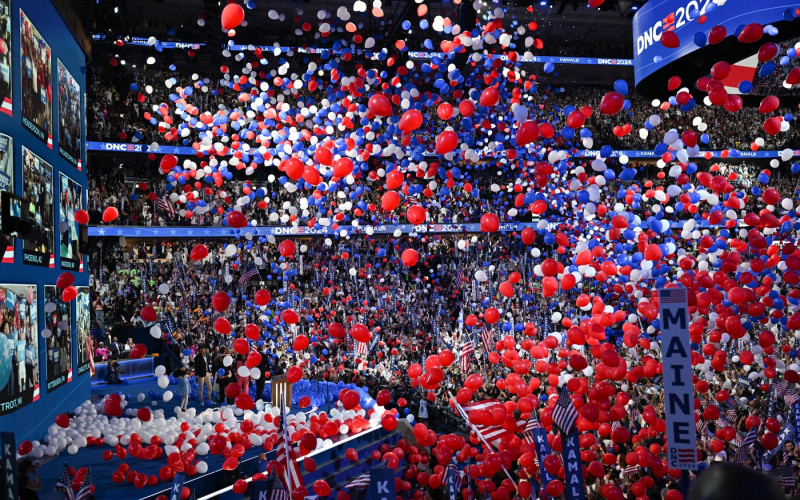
[633,0,800,85]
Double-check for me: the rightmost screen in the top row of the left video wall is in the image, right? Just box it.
[58,59,83,167]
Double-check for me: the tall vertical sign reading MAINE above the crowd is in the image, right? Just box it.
[658,288,697,470]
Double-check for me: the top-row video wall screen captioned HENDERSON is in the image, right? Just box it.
[19,10,53,149]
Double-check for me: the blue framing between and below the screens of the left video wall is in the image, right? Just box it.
[0,0,90,442]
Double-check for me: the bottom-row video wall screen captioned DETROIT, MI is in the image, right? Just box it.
[0,284,39,415]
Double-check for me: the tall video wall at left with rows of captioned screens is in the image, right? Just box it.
[0,0,86,422]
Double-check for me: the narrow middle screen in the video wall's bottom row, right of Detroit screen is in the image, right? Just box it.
[42,285,72,392]
